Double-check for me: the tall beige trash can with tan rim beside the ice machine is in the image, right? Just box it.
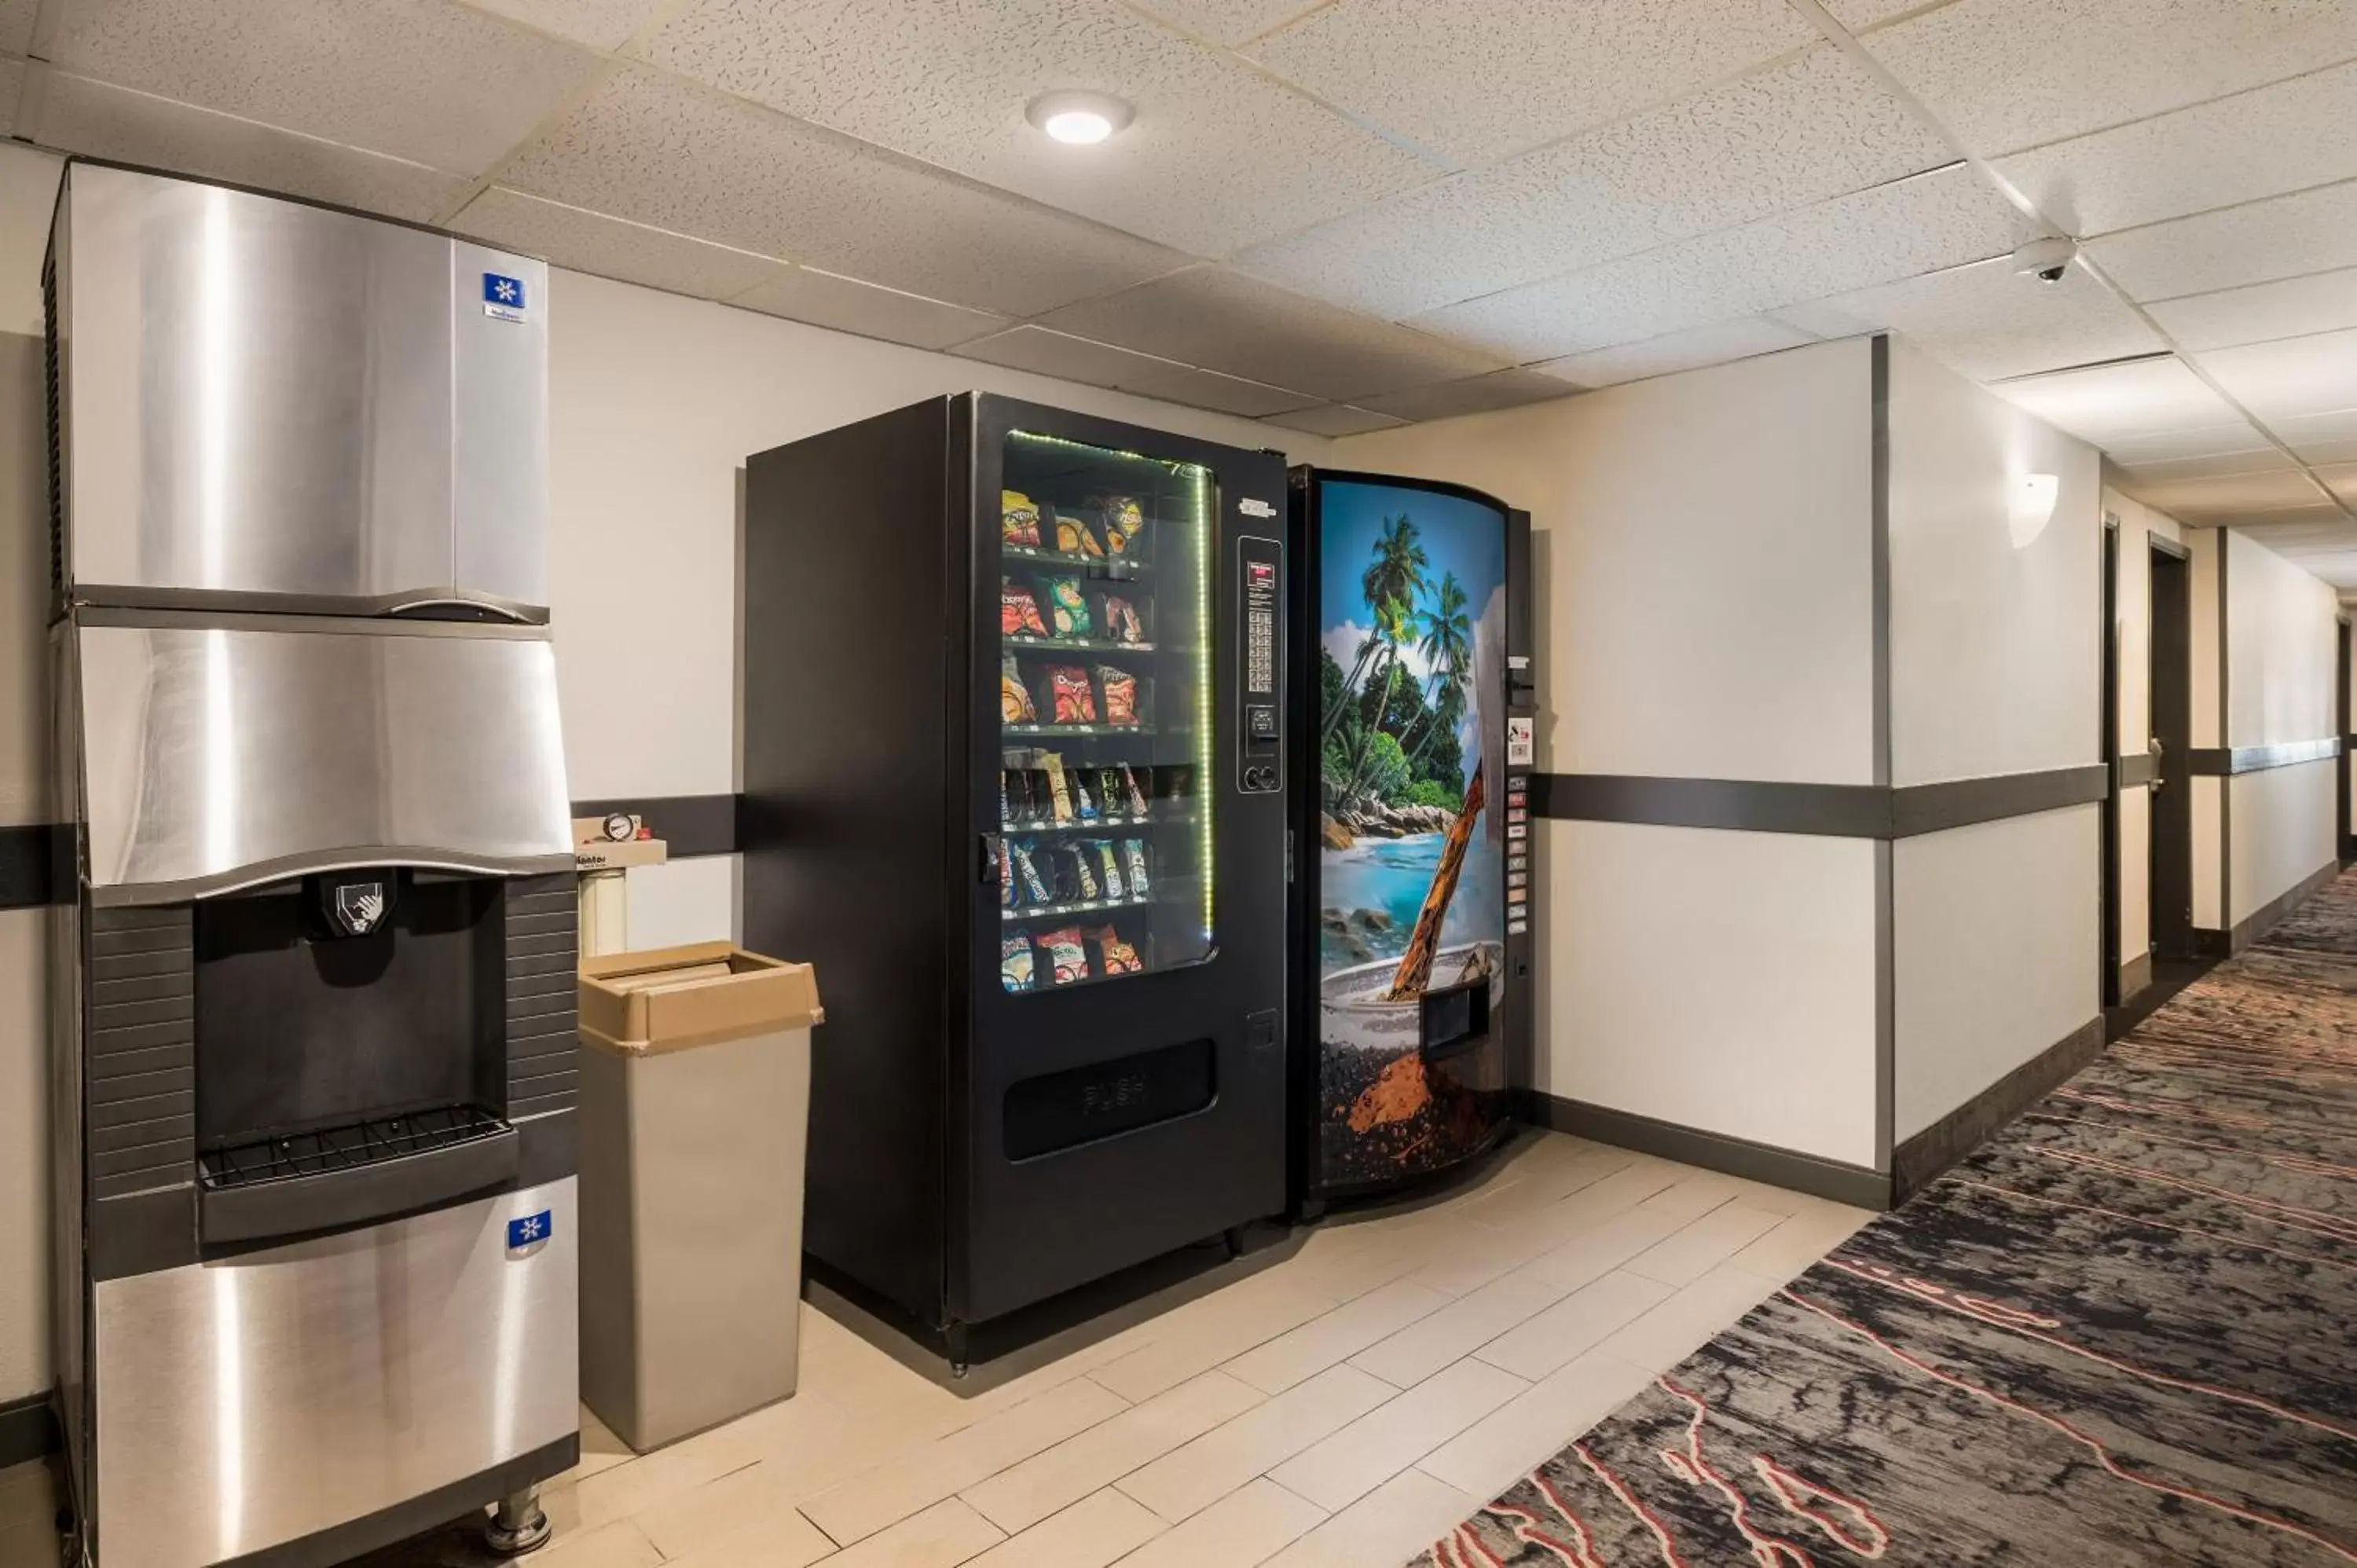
[580,941,823,1453]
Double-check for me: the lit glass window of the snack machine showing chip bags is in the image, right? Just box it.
[997,429,1219,993]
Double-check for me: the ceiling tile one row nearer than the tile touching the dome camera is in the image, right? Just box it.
[1237,45,1949,318]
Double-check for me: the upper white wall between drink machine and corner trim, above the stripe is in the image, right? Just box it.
[1334,339,1874,782]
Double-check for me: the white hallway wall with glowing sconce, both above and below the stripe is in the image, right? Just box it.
[1888,342,2105,1141]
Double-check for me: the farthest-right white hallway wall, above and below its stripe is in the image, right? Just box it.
[2220,530,2341,927]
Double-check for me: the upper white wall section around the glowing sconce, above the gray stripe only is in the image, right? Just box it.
[1890,342,2102,786]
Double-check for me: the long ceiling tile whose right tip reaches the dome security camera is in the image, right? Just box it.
[1414,163,2029,363]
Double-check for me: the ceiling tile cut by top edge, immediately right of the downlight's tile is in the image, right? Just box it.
[1249,0,1817,165]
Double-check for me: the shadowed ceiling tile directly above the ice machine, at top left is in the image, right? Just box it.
[31,71,467,222]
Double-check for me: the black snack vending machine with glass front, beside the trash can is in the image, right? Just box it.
[742,394,1292,1361]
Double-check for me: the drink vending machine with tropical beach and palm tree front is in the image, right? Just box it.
[1289,467,1537,1217]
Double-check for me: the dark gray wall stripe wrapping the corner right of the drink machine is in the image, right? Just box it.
[1530,761,2110,840]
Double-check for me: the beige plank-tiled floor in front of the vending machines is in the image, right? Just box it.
[0,1134,1867,1568]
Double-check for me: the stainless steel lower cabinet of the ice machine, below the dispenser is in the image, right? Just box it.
[92,1177,580,1568]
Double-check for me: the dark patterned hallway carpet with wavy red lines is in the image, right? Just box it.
[1417,873,2357,1568]
